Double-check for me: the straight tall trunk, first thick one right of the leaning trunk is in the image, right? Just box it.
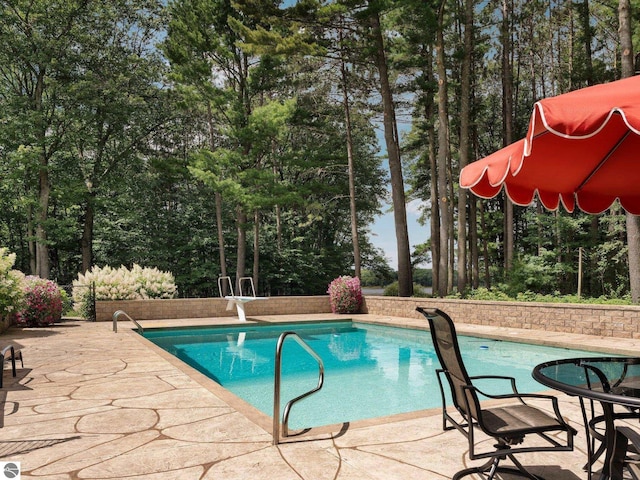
[436,2,451,297]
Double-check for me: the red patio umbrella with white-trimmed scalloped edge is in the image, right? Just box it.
[460,76,640,215]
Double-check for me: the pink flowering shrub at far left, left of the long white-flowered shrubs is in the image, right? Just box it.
[16,275,62,327]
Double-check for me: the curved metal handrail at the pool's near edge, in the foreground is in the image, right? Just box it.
[273,332,324,445]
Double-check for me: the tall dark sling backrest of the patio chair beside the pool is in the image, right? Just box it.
[416,307,480,420]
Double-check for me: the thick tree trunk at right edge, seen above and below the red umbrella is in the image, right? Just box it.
[618,0,640,303]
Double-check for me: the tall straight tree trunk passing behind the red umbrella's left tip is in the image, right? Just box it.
[458,0,474,293]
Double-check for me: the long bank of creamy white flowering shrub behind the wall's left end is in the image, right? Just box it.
[72,265,178,316]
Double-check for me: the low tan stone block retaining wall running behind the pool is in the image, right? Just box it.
[96,296,640,338]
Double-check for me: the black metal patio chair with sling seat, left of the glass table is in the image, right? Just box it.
[416,307,577,480]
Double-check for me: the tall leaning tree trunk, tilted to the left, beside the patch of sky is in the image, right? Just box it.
[369,11,413,297]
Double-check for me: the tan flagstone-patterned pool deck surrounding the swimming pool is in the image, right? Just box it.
[0,315,640,480]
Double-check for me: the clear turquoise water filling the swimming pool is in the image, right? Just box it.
[144,321,600,428]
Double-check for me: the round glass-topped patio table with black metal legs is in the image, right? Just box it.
[533,357,640,480]
